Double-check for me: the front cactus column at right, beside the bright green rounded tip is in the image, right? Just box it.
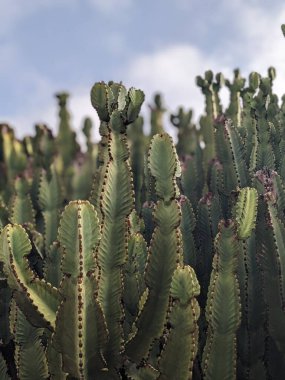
[203,222,241,380]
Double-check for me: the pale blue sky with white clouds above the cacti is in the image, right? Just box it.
[0,0,285,140]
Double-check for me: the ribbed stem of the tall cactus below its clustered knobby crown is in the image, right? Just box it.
[98,137,132,361]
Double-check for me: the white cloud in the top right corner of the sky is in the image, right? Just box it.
[221,0,285,95]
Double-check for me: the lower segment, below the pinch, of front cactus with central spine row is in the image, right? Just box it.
[52,274,107,379]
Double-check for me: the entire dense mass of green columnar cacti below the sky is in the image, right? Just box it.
[0,43,285,380]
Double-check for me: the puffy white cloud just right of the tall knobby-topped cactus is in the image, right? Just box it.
[125,45,231,137]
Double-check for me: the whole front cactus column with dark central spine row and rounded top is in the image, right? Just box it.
[52,201,107,378]
